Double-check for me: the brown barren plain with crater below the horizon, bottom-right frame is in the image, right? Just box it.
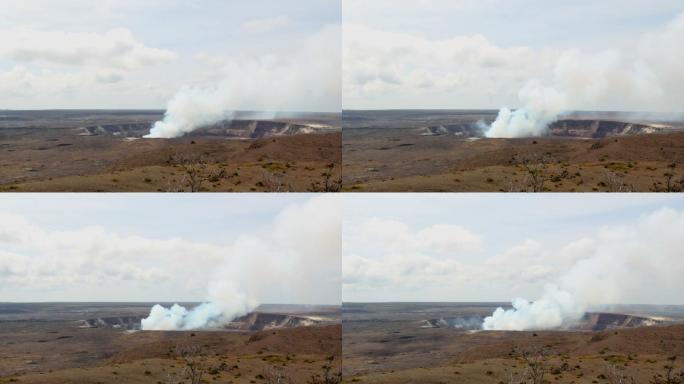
[343,303,684,384]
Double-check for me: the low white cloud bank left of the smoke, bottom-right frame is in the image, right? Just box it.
[342,242,563,301]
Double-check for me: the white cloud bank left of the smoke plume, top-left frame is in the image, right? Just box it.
[0,27,176,108]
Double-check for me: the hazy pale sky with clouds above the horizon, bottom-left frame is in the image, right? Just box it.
[0,194,341,304]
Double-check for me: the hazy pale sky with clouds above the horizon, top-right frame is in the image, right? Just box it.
[343,0,684,112]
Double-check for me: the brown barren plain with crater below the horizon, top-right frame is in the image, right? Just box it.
[342,110,684,192]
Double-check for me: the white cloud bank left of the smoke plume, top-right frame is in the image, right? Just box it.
[343,24,554,108]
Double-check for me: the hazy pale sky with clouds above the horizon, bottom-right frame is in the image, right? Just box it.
[342,194,684,304]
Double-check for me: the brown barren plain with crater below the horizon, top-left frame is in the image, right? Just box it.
[0,110,341,192]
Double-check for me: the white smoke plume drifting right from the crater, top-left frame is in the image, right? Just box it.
[146,25,341,138]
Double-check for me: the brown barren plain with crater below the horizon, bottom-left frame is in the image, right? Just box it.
[0,303,341,384]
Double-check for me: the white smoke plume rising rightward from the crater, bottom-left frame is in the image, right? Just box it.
[141,196,342,330]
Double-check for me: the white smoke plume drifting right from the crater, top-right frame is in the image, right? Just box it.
[485,13,684,138]
